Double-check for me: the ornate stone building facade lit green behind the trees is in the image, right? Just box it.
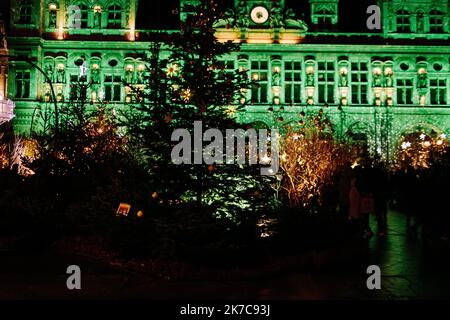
[8,0,450,158]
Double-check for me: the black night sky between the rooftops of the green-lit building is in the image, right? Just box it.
[136,0,377,31]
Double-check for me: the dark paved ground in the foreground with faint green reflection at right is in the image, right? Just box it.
[0,212,450,300]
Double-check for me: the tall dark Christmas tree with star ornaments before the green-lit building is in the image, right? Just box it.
[127,0,259,220]
